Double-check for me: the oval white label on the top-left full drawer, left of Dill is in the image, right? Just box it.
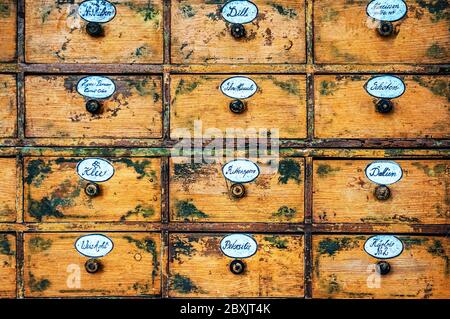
[78,0,116,23]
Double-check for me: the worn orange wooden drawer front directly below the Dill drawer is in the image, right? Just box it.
[170,75,306,138]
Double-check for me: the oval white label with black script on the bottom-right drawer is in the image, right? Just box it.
[364,235,403,259]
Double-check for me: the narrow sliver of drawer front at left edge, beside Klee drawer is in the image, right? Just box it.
[0,158,18,222]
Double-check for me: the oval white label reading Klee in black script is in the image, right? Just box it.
[77,158,114,182]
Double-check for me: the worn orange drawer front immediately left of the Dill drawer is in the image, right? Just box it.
[25,0,163,63]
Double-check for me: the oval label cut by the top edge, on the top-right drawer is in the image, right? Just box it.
[366,0,408,22]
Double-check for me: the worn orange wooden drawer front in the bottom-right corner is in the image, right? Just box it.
[313,235,450,299]
